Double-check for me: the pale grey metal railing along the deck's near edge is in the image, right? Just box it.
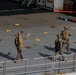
[0,54,76,75]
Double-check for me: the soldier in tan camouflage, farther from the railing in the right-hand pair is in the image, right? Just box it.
[61,27,71,53]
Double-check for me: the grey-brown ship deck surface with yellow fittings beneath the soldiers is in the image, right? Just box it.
[0,0,76,75]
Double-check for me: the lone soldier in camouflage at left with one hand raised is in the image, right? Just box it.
[15,31,30,60]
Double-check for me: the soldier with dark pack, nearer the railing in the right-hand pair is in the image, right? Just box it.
[55,34,65,61]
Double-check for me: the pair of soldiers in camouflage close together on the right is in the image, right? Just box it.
[55,27,71,61]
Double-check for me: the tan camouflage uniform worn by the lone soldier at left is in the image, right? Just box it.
[15,32,23,60]
